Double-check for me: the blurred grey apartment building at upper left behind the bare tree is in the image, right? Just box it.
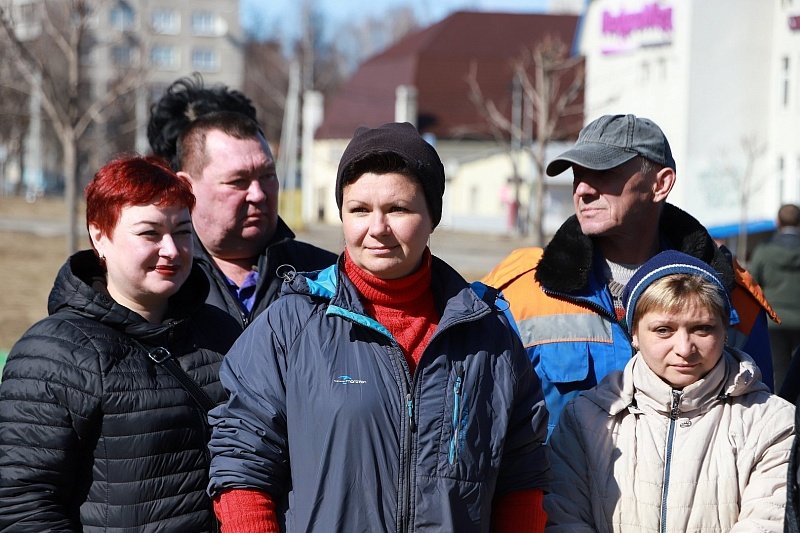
[0,0,244,196]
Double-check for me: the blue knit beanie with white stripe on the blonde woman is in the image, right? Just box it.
[622,250,734,332]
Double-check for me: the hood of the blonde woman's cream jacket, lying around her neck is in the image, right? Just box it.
[583,347,769,416]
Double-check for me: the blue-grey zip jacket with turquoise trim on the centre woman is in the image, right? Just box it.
[209,258,548,532]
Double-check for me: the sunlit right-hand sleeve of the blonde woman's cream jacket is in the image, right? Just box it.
[731,397,795,533]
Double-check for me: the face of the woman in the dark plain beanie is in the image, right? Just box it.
[342,172,433,279]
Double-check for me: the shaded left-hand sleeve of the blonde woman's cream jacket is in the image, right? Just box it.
[544,401,597,533]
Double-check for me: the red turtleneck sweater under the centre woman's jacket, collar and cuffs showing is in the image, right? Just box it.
[214,249,547,533]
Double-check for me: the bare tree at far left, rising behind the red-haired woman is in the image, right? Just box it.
[0,0,140,253]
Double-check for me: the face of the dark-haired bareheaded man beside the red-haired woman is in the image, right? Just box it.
[187,130,278,260]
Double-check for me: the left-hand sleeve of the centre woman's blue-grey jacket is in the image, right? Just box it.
[208,299,299,500]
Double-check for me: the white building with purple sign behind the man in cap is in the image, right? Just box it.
[577,0,800,237]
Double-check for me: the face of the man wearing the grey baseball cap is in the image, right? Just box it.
[572,157,658,237]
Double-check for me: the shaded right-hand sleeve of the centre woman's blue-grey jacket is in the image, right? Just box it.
[497,329,550,495]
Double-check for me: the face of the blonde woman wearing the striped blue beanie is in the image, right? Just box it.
[633,299,725,389]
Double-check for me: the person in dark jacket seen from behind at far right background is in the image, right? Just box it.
[748,204,800,390]
